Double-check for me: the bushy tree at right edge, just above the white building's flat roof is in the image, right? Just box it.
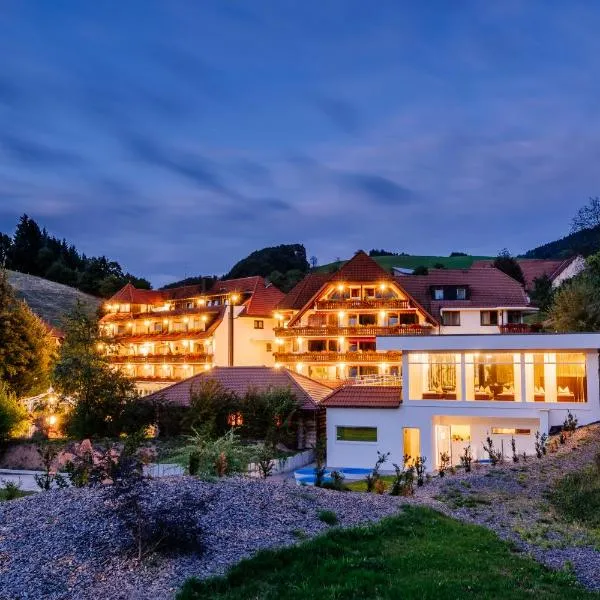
[548,272,600,332]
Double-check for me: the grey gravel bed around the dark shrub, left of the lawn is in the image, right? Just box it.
[0,477,401,600]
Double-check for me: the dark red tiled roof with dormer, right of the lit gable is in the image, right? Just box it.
[396,267,530,318]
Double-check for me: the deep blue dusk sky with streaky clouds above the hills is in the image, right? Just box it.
[0,0,600,286]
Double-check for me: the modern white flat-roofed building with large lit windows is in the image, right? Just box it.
[323,333,600,470]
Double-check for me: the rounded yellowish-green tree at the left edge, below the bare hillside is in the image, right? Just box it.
[0,270,56,398]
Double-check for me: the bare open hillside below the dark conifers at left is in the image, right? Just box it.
[8,271,101,328]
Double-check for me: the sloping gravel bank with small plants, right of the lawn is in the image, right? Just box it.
[409,424,600,590]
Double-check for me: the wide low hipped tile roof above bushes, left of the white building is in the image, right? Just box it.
[145,367,331,410]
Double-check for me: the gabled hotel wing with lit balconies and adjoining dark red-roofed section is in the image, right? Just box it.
[275,251,536,384]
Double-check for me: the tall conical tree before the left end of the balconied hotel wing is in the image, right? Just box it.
[54,304,155,438]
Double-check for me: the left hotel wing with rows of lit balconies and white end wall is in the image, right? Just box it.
[100,277,284,393]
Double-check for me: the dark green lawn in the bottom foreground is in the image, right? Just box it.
[177,507,600,600]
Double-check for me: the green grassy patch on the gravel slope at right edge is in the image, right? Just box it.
[549,465,600,529]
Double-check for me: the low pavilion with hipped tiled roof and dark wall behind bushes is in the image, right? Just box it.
[148,367,331,449]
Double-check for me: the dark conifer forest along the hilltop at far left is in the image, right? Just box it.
[0,215,151,298]
